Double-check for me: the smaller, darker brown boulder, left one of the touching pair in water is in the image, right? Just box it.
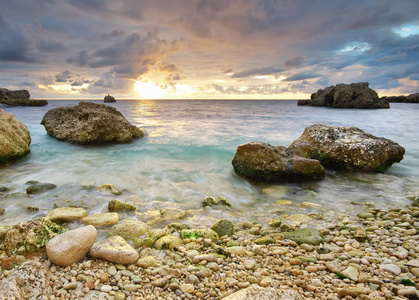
[232,142,325,184]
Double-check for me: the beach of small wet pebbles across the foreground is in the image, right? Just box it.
[0,193,419,299]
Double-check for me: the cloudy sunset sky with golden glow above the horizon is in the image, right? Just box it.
[0,0,419,99]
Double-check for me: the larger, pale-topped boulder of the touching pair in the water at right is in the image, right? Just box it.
[289,124,405,172]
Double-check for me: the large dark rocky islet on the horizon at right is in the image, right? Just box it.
[298,82,390,108]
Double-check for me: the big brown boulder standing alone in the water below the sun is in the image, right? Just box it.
[41,102,144,145]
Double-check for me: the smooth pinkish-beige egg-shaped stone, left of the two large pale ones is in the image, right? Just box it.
[46,225,97,267]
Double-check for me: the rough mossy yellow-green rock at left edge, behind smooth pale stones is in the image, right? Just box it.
[0,219,65,256]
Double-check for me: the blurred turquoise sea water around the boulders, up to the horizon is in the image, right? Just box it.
[0,100,419,226]
